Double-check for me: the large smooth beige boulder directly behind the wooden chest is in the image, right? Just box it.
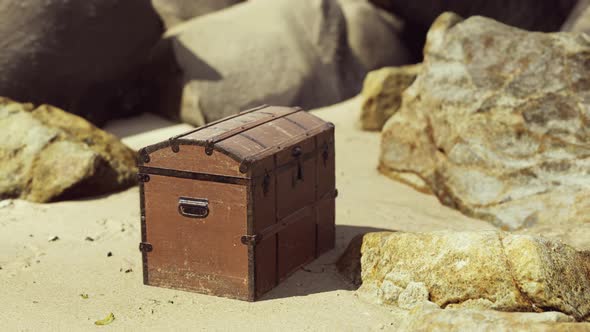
[159,0,406,125]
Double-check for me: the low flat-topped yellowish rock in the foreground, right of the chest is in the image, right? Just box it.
[349,231,590,321]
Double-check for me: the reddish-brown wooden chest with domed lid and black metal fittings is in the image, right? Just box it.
[138,106,336,301]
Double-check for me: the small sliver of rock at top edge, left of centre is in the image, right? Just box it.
[152,0,243,28]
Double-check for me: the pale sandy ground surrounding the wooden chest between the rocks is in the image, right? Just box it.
[0,99,504,331]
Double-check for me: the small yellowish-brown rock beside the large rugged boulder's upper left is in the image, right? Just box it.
[361,64,421,130]
